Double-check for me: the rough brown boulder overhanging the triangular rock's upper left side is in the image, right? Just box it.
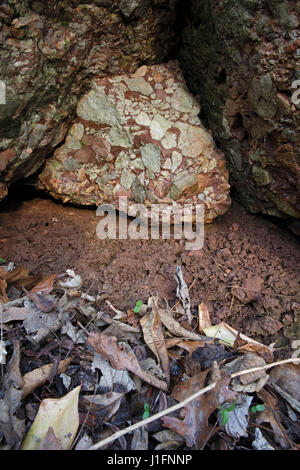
[0,0,177,200]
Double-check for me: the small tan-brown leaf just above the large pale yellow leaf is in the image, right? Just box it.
[22,357,73,398]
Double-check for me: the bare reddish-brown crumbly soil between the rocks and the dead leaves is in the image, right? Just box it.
[0,193,300,357]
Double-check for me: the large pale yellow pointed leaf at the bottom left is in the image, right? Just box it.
[21,386,80,450]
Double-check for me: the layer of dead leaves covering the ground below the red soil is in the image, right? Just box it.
[0,265,300,450]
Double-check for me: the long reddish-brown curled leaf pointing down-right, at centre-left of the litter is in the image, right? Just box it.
[88,332,168,391]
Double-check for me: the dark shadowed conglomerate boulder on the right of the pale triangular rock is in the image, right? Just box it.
[180,0,300,229]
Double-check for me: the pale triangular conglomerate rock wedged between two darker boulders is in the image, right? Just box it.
[40,61,230,223]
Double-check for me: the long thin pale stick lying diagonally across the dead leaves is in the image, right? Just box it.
[87,358,300,450]
